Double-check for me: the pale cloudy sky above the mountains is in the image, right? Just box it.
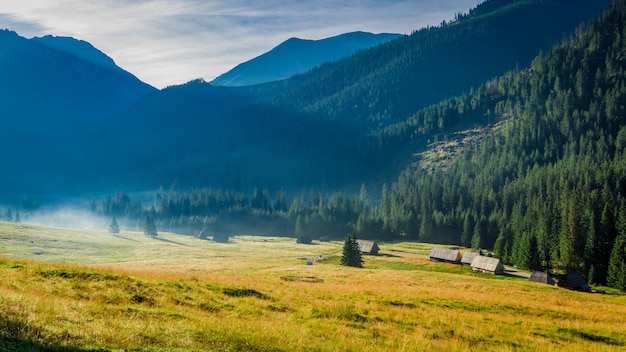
[0,0,482,88]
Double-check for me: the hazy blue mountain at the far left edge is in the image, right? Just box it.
[0,30,157,201]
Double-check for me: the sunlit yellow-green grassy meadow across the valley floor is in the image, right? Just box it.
[0,223,626,351]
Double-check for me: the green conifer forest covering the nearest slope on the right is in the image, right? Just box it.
[372,2,626,287]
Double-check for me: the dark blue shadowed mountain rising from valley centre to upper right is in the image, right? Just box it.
[91,0,609,195]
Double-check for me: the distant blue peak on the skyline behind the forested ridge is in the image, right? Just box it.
[211,32,401,87]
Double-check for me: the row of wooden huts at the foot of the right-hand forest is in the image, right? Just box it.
[430,247,591,291]
